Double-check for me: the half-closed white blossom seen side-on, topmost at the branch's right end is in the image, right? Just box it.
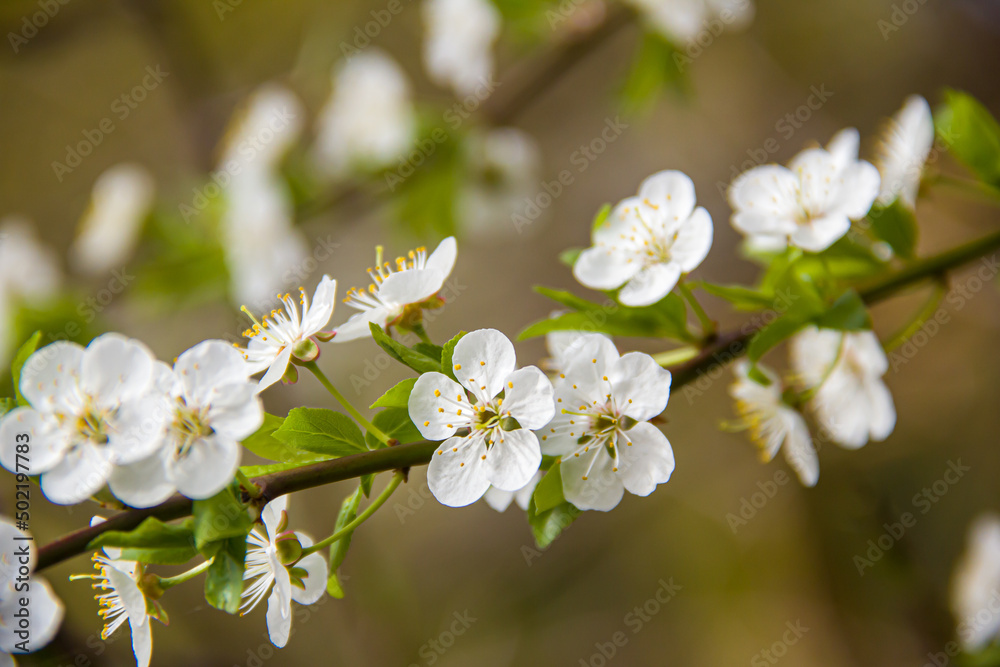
[875,95,934,209]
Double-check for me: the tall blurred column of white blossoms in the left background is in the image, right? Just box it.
[217,84,306,306]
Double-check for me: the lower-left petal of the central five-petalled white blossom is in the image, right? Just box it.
[427,436,490,507]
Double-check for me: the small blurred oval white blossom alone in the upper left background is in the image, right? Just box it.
[70,164,156,273]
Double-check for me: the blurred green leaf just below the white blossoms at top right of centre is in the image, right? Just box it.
[621,30,690,113]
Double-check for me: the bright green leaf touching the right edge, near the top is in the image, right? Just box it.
[934,90,1000,186]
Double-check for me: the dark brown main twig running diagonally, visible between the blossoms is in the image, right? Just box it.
[37,227,1000,570]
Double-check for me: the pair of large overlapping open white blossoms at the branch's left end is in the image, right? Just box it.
[0,334,263,507]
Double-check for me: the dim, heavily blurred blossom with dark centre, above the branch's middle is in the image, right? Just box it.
[455,127,542,239]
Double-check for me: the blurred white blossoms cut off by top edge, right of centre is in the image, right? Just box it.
[629,0,755,46]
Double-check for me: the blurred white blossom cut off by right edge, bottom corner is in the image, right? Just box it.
[951,514,1000,652]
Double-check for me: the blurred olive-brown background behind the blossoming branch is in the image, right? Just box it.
[0,0,1000,667]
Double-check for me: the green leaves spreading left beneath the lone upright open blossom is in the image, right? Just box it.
[518,287,692,342]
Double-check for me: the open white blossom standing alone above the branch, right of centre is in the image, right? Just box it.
[573,171,712,306]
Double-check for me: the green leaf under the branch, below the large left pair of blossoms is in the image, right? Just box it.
[87,517,198,565]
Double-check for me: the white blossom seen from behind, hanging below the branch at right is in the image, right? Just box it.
[789,326,896,449]
